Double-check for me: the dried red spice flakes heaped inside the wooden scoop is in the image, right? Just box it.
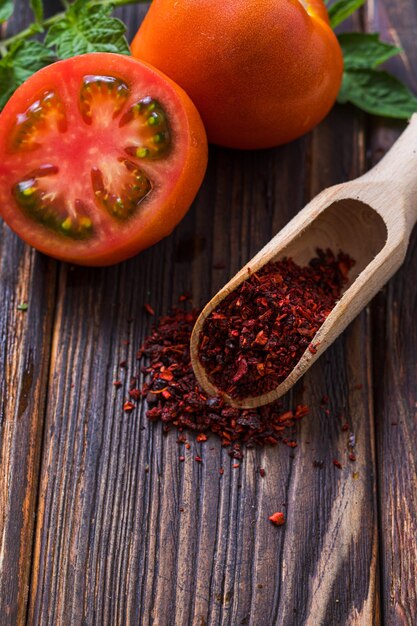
[199,250,354,399]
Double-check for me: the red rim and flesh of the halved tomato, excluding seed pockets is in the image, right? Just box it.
[0,53,207,266]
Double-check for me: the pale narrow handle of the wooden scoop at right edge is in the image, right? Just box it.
[357,113,417,230]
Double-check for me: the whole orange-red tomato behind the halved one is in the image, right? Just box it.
[131,0,343,148]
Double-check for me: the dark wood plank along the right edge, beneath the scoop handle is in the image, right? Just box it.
[368,0,417,625]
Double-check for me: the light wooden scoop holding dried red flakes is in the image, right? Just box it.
[191,113,417,408]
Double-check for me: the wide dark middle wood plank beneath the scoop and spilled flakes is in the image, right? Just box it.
[23,9,379,626]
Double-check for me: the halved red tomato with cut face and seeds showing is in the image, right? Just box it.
[0,53,207,265]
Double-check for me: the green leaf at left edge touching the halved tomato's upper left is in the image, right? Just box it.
[0,40,55,109]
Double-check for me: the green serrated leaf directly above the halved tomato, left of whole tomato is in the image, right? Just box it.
[45,0,130,59]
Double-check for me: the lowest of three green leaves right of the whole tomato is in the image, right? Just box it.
[337,69,417,119]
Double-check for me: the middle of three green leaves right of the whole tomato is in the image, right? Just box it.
[337,33,402,70]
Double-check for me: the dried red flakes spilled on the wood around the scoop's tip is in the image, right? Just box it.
[138,309,308,459]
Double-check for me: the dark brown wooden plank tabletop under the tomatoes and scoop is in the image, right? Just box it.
[0,0,417,626]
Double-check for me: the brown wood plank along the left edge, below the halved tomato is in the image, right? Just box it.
[0,0,56,626]
